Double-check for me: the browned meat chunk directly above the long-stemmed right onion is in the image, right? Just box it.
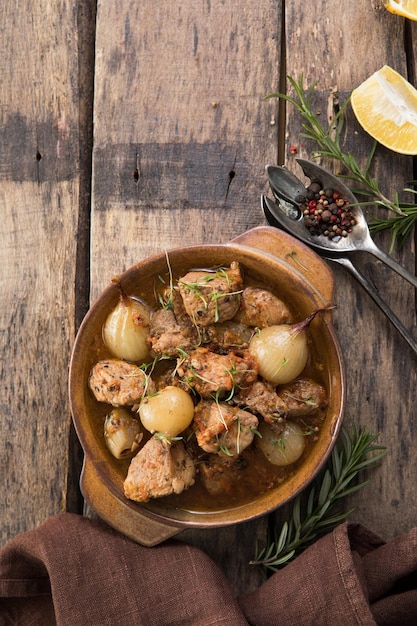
[234,287,292,328]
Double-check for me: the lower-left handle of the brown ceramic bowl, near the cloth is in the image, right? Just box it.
[80,458,182,547]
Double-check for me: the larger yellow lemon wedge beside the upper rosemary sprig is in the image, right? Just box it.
[351,65,417,154]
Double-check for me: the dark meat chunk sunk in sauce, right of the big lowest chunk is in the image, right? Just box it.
[199,454,248,496]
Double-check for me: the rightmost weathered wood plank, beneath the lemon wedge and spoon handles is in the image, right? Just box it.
[280,0,417,539]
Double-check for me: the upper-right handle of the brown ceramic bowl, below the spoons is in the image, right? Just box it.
[230,226,334,304]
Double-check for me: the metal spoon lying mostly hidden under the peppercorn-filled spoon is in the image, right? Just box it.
[262,196,417,353]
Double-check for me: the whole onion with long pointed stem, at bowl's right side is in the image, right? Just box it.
[249,309,322,385]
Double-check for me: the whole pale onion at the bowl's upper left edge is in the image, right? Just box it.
[103,286,150,363]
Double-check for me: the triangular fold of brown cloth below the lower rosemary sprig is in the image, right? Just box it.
[240,525,375,626]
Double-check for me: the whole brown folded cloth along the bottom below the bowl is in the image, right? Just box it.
[0,513,417,626]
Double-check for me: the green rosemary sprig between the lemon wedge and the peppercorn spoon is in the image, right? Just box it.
[267,75,417,251]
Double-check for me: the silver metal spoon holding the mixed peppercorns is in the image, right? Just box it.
[266,159,417,287]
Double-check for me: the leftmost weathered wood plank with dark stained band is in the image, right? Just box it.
[0,0,90,543]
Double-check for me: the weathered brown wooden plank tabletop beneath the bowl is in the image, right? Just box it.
[0,0,417,593]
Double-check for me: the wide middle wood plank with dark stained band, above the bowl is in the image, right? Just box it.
[91,0,281,591]
